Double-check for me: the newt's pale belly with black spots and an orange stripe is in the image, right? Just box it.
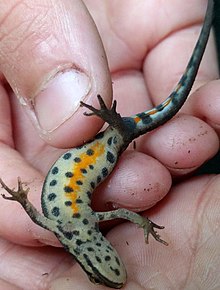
[42,128,123,222]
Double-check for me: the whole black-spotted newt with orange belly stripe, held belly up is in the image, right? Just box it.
[0,0,214,288]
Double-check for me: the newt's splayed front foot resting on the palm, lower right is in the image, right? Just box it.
[140,218,168,246]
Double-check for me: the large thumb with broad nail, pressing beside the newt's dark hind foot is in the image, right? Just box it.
[0,0,111,147]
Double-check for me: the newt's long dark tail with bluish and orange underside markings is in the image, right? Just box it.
[128,0,214,137]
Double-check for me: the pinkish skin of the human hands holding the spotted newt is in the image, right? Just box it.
[0,0,220,290]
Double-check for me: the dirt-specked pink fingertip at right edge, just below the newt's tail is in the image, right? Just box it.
[140,114,219,175]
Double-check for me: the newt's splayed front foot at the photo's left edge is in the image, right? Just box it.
[0,177,29,206]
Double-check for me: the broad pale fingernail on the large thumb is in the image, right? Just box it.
[33,69,91,132]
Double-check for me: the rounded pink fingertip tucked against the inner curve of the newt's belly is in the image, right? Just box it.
[92,150,172,211]
